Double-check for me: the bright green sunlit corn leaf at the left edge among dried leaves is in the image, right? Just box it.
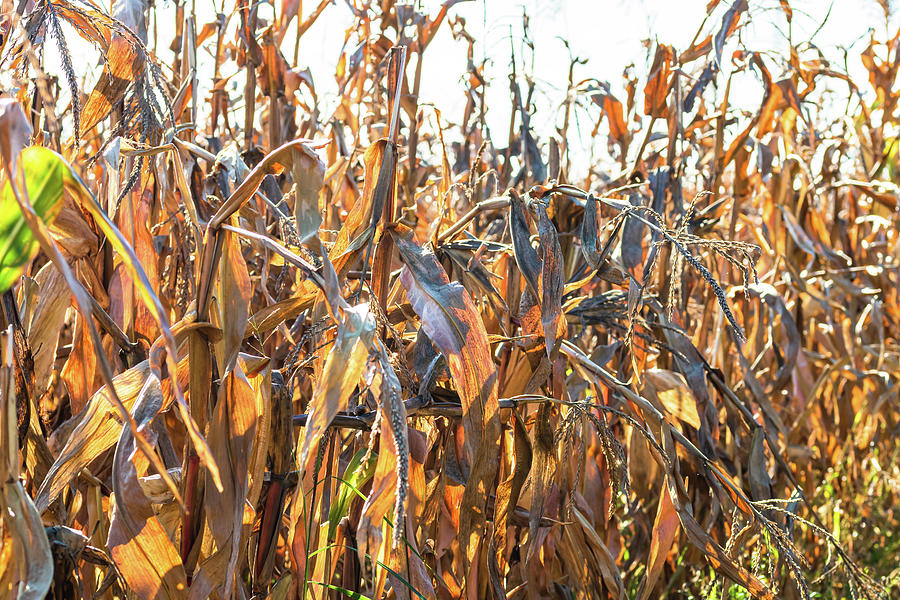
[0,146,69,293]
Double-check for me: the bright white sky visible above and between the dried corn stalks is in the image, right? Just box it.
[37,0,898,168]
